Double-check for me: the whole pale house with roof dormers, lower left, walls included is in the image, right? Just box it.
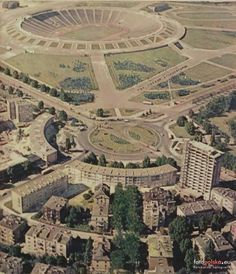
[23,225,72,258]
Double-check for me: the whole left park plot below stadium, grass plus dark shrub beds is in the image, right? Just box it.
[7,53,97,90]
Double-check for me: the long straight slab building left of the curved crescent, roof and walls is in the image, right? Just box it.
[11,169,68,213]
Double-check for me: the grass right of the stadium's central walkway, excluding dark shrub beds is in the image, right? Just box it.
[105,47,186,89]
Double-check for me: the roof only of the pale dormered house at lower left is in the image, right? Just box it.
[26,225,72,244]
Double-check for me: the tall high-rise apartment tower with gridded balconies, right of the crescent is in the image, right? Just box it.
[180,140,223,200]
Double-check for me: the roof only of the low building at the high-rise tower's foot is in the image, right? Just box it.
[178,200,220,216]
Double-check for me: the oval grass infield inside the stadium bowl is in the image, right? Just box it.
[63,26,120,41]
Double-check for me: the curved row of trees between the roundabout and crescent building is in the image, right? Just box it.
[83,152,177,169]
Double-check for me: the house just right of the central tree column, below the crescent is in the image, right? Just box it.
[143,187,176,229]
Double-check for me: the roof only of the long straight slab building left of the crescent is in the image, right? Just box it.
[12,169,67,197]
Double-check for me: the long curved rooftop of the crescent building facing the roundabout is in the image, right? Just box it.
[67,160,177,177]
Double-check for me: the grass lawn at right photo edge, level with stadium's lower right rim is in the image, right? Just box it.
[183,28,236,49]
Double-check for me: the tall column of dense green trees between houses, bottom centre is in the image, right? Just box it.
[111,184,147,273]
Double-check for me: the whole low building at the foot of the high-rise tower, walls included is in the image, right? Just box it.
[177,200,221,221]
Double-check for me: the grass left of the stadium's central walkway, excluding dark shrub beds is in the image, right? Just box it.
[7,53,98,89]
